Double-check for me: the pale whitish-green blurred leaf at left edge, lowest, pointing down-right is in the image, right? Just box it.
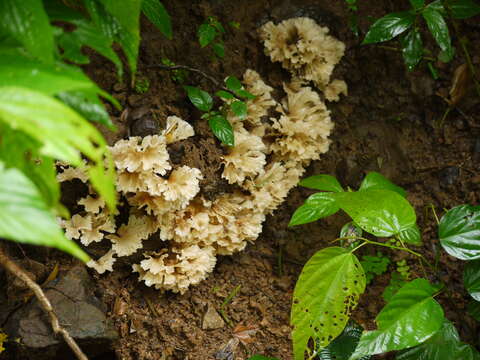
[0,162,89,262]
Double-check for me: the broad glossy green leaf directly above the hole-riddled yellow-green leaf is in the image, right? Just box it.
[334,190,416,237]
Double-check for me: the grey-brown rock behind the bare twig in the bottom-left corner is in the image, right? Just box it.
[4,265,118,360]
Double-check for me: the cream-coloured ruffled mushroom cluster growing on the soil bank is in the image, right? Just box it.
[58,19,343,293]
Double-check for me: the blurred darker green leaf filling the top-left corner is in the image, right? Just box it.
[0,0,55,63]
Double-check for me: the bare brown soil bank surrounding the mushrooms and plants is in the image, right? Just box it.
[0,0,480,360]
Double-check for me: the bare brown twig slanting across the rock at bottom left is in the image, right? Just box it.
[0,249,88,360]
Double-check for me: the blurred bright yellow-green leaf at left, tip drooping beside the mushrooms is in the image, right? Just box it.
[0,87,116,212]
